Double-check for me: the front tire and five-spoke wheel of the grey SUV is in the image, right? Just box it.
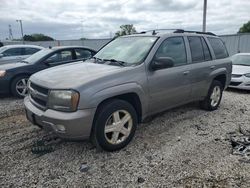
[92,99,138,151]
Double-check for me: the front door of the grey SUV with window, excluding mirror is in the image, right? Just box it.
[148,36,191,113]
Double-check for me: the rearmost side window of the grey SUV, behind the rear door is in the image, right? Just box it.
[208,38,228,59]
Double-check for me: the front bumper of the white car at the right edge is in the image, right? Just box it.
[228,75,250,90]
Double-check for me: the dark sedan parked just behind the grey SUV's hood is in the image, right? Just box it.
[0,46,96,97]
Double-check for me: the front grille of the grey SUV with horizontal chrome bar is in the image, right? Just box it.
[29,82,49,110]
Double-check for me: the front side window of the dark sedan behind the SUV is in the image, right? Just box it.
[45,50,72,64]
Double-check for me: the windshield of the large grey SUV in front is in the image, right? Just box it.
[95,36,157,65]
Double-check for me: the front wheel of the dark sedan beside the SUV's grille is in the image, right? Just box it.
[10,75,29,98]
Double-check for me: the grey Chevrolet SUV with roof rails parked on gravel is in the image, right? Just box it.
[24,30,232,151]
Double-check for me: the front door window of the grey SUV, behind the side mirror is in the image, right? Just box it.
[155,37,187,66]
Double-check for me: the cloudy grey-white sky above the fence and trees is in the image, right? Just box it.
[0,0,250,40]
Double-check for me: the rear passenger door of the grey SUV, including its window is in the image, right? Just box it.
[187,36,212,100]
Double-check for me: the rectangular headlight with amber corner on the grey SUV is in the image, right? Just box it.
[48,90,80,112]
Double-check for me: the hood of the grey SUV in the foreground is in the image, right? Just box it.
[30,61,126,89]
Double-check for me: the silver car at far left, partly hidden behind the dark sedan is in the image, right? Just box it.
[0,45,44,65]
